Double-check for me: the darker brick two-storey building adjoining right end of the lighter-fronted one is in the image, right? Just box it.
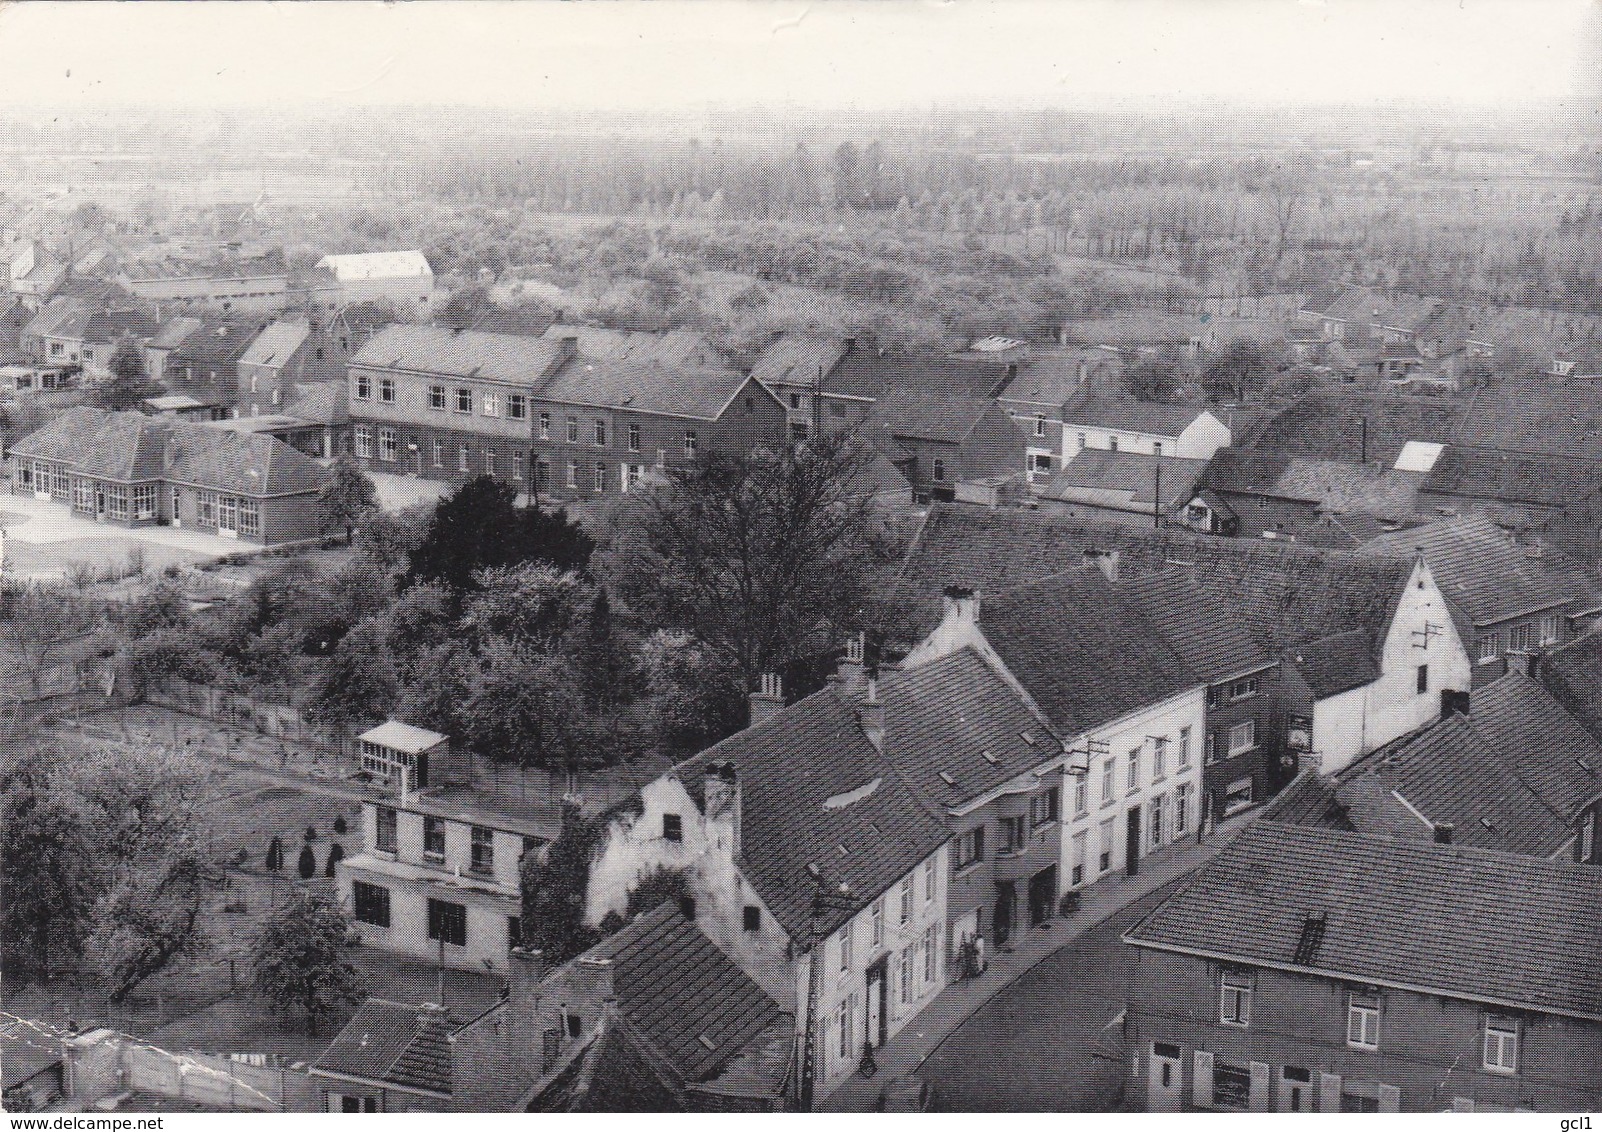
[530,349,788,500]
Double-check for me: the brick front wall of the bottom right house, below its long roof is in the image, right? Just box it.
[1128,948,1602,1113]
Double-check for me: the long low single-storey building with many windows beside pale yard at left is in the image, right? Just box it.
[8,405,328,544]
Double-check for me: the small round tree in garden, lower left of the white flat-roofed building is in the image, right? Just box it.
[252,892,364,1036]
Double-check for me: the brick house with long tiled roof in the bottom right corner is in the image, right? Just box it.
[1123,821,1602,1113]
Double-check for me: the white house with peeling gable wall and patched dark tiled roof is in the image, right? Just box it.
[588,687,947,1095]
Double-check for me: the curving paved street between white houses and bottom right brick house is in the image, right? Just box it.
[918,879,1182,1113]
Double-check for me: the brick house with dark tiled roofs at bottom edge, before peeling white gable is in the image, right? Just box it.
[450,903,795,1113]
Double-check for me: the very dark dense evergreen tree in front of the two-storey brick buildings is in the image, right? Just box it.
[407,476,594,594]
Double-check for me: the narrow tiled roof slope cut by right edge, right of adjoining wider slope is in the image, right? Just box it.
[1469,671,1602,821]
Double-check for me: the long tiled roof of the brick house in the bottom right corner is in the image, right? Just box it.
[1125,821,1602,1020]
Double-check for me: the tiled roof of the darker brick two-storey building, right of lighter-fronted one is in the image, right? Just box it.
[531,351,774,421]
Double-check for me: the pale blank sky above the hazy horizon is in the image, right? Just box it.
[0,0,1602,112]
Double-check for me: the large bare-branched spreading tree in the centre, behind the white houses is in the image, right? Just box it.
[607,436,883,688]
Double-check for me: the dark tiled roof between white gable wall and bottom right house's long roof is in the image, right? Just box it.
[1336,714,1573,857]
